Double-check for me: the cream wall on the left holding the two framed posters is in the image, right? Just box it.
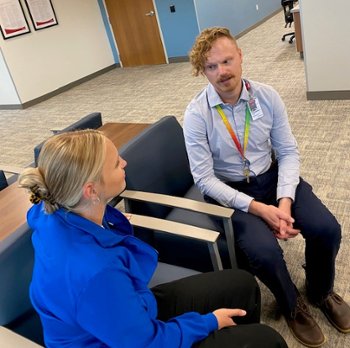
[0,0,114,104]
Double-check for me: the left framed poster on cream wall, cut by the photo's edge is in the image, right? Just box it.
[0,0,30,40]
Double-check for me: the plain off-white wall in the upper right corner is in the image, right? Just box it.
[299,0,350,92]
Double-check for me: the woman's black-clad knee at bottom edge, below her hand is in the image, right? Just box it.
[193,324,288,348]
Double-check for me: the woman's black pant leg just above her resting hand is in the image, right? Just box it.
[152,269,261,323]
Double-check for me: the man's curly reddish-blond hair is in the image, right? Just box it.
[189,27,237,76]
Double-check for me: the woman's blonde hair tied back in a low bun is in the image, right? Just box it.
[18,129,106,213]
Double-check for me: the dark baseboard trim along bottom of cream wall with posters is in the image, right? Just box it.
[0,63,120,110]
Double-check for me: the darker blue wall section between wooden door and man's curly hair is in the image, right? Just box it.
[155,0,199,58]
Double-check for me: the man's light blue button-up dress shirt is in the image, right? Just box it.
[184,81,300,212]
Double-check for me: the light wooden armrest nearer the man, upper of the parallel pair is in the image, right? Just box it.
[120,190,234,219]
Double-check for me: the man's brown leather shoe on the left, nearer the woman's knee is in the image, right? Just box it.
[286,296,326,347]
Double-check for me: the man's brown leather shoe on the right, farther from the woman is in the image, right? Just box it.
[319,292,350,333]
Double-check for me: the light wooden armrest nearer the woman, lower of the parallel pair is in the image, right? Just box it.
[130,214,220,243]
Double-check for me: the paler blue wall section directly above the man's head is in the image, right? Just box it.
[194,0,281,35]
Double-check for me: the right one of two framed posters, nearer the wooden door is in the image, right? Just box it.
[25,0,58,30]
